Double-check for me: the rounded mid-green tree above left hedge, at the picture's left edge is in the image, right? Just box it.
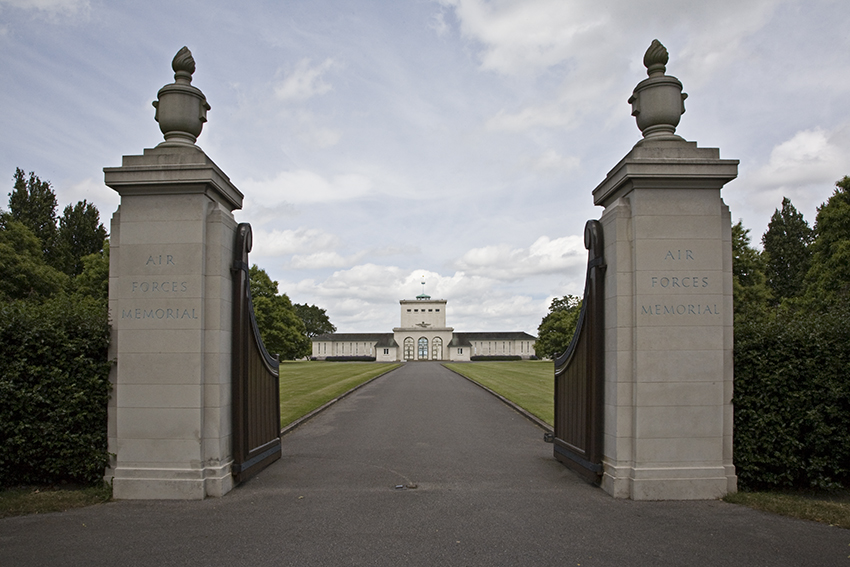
[0,213,68,300]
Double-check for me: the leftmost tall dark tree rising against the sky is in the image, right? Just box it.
[9,168,57,264]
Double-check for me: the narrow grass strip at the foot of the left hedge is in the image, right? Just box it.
[0,484,112,518]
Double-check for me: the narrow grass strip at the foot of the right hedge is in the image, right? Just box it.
[723,490,850,529]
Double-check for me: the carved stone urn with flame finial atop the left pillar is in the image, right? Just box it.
[153,47,210,147]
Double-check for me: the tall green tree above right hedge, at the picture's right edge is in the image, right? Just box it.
[806,176,850,306]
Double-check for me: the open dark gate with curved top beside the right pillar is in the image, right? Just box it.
[554,220,606,482]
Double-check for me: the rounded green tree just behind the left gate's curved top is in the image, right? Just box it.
[249,264,311,360]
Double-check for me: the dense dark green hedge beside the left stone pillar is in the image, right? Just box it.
[0,296,110,487]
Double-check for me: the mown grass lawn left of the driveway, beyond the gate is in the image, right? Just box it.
[280,361,400,427]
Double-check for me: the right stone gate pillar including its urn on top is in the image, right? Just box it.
[593,40,738,500]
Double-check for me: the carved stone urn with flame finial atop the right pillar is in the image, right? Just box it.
[629,39,688,143]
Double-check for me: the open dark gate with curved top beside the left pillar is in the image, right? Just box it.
[231,223,280,484]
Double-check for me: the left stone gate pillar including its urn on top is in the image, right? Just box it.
[104,47,242,499]
